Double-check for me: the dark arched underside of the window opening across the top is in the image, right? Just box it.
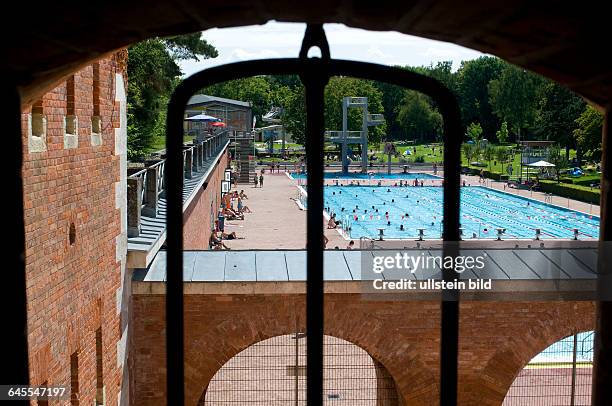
[0,0,612,105]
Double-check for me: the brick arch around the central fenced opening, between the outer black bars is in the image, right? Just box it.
[179,295,439,405]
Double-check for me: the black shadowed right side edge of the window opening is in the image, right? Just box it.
[592,105,612,406]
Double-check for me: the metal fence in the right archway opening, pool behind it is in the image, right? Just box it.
[503,331,594,406]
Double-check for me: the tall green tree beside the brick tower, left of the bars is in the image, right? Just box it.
[127,33,217,159]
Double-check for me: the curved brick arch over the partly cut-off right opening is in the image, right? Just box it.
[464,302,595,405]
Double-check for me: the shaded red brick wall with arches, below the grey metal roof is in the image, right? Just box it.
[132,294,595,406]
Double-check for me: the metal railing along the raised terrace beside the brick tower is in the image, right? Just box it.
[127,130,228,238]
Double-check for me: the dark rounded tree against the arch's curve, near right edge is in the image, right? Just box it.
[536,81,585,159]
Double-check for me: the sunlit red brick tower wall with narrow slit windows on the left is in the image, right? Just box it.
[22,52,127,405]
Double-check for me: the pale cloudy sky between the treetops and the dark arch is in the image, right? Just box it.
[180,21,483,76]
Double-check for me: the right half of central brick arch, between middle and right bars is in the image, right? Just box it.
[325,297,440,406]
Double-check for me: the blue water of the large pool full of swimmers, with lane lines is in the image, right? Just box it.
[324,186,599,239]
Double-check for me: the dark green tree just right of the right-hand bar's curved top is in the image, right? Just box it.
[456,56,507,138]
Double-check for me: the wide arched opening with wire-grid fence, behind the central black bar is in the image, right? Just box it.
[198,332,402,406]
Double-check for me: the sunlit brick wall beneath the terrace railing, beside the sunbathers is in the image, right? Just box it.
[183,151,229,250]
